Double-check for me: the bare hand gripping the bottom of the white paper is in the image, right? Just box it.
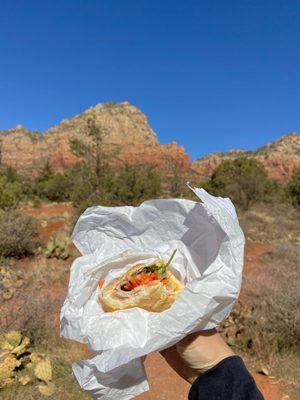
[161,329,234,383]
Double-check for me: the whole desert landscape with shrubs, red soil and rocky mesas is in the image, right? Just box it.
[0,102,300,400]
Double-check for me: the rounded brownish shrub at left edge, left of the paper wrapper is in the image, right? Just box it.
[0,210,39,258]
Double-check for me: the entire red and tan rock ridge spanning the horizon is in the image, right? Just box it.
[0,102,300,183]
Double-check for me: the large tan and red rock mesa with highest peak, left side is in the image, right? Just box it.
[0,102,190,172]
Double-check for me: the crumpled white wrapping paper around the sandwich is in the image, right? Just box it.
[61,188,244,400]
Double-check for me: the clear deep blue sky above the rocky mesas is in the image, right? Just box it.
[0,0,300,159]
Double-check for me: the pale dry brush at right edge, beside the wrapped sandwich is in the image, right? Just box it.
[245,244,300,353]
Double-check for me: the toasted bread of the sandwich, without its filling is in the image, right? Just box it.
[99,264,183,312]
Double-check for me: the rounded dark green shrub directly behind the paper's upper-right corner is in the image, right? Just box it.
[205,158,283,209]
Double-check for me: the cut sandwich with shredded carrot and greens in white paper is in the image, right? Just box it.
[99,250,183,312]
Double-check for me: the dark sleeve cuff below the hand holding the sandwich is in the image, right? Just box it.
[188,356,263,400]
